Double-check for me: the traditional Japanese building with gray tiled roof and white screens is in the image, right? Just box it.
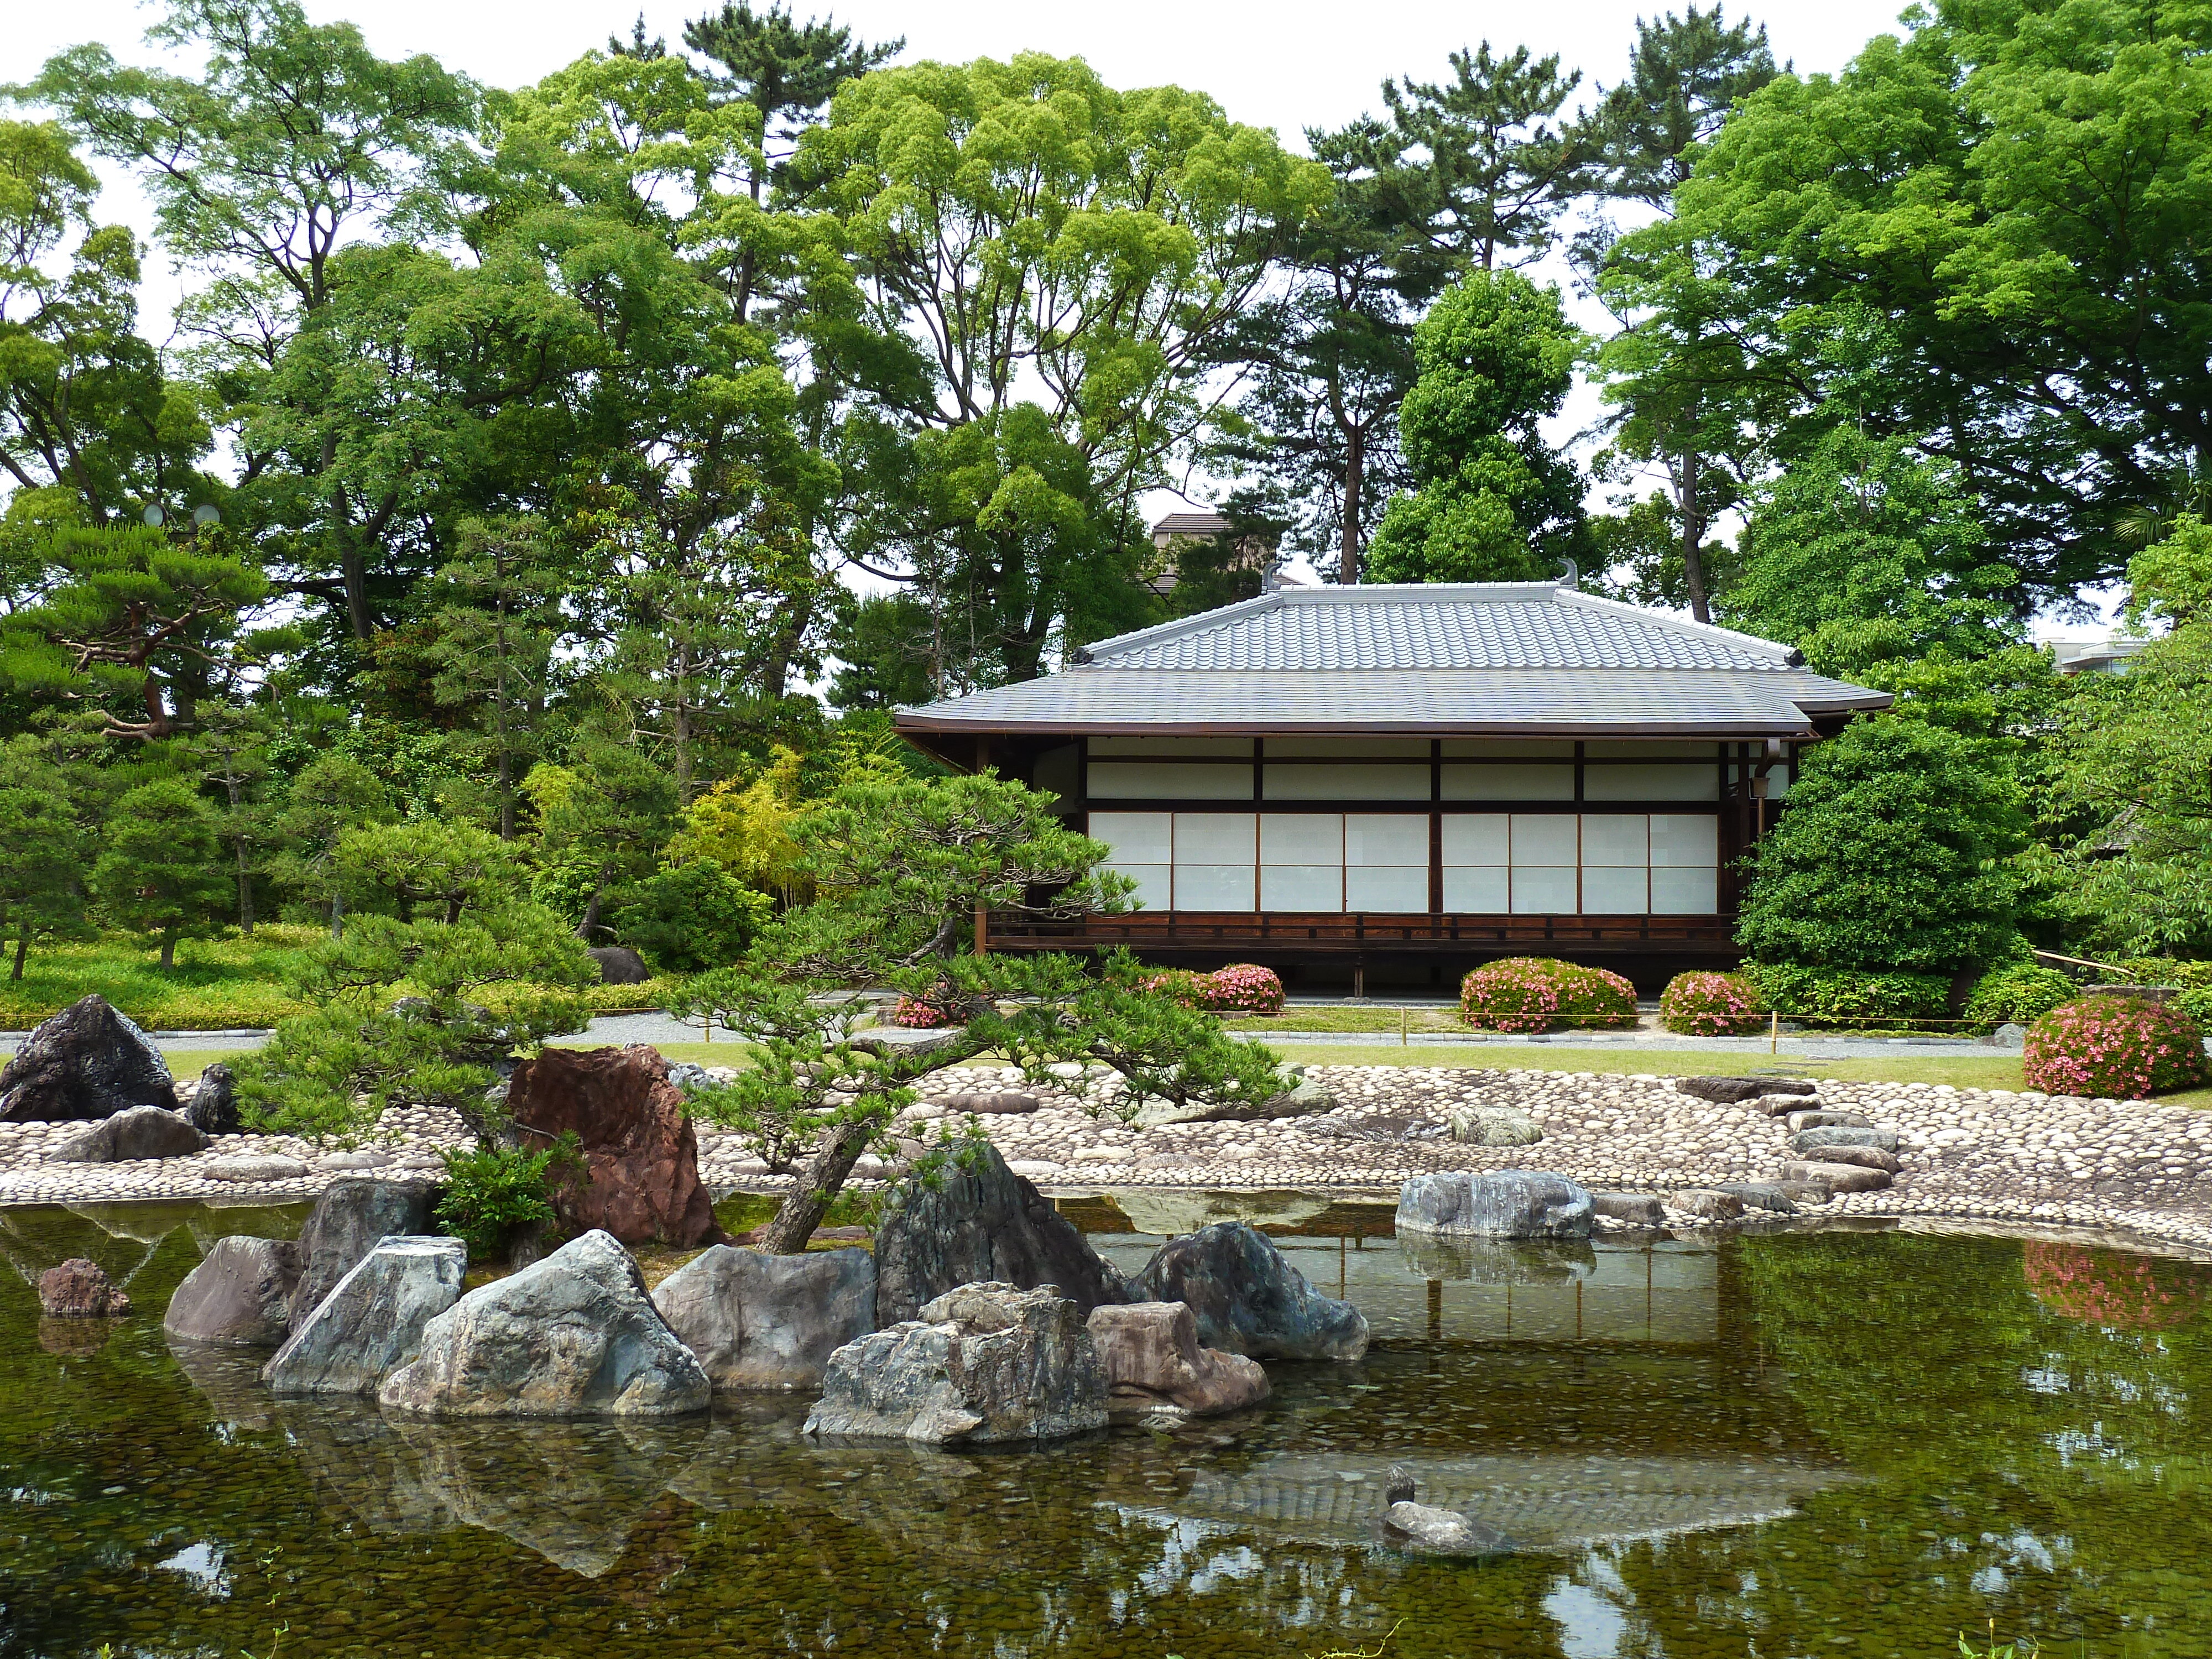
[898,582,1891,987]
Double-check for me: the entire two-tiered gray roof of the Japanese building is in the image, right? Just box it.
[898,582,1891,737]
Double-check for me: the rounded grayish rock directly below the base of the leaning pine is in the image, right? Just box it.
[653,1245,876,1389]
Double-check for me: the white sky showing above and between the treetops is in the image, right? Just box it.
[22,0,2106,637]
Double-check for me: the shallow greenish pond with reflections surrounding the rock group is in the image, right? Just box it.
[0,1192,2212,1659]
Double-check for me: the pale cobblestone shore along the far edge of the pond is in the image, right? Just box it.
[0,1066,2212,1250]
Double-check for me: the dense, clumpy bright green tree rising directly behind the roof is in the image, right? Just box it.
[1369,270,1584,582]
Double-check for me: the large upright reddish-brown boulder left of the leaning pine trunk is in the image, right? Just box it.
[507,1044,714,1248]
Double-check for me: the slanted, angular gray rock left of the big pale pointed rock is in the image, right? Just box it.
[261,1239,469,1394]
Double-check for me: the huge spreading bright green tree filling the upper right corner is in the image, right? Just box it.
[1606,0,2212,611]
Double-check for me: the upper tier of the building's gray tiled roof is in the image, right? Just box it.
[1086,582,1792,670]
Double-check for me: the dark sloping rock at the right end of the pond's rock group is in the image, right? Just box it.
[1139,1221,1367,1360]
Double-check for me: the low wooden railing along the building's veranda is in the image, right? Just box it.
[989,909,1736,956]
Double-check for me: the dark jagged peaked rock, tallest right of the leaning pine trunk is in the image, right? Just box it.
[876,1141,1130,1325]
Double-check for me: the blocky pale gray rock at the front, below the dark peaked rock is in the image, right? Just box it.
[805,1285,1106,1444]
